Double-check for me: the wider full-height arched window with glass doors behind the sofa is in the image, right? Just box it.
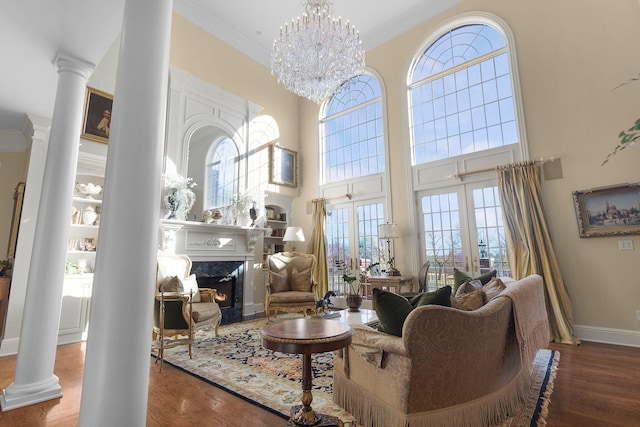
[407,15,526,288]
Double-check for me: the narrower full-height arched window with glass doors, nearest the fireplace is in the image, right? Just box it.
[320,74,386,296]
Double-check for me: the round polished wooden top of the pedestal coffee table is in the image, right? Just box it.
[260,318,353,354]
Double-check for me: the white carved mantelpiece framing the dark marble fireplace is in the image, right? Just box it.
[159,219,264,321]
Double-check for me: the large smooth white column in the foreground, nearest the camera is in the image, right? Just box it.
[79,0,172,427]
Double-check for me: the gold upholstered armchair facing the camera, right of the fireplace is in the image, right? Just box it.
[265,252,318,323]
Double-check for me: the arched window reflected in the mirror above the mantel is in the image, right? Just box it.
[206,137,239,209]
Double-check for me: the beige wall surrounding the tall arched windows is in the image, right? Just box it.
[295,0,640,331]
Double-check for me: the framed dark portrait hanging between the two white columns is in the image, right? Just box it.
[81,86,113,144]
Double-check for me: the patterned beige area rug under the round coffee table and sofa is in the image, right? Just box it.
[156,319,560,427]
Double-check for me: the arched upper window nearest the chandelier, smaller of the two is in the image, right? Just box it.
[320,74,385,184]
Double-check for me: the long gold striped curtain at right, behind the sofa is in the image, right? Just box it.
[496,161,580,344]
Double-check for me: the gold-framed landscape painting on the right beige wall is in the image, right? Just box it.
[573,183,640,237]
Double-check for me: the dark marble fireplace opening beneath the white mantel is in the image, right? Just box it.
[191,261,244,325]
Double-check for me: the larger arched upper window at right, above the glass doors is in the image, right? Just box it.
[409,24,519,164]
